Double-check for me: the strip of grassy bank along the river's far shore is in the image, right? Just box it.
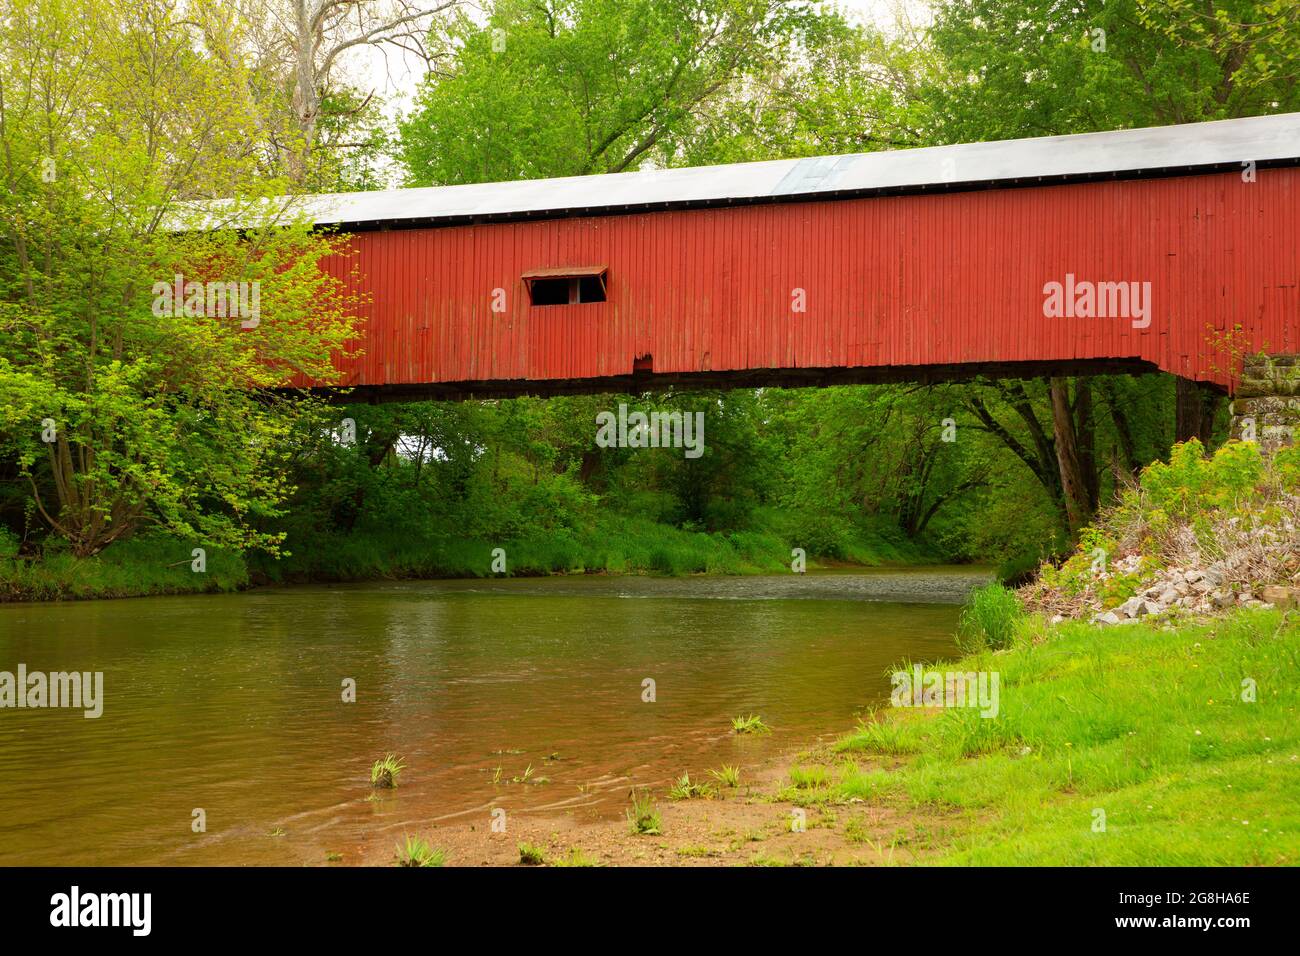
[0,515,936,601]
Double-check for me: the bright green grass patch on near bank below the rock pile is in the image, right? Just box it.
[832,610,1300,866]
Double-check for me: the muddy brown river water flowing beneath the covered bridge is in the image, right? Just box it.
[0,567,988,865]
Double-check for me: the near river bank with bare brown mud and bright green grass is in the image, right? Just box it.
[374,610,1300,866]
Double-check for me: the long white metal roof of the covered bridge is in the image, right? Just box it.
[250,113,1300,225]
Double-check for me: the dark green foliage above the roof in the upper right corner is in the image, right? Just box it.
[922,0,1300,142]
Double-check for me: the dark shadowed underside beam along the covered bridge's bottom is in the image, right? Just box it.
[312,358,1175,405]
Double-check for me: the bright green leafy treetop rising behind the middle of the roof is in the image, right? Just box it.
[400,0,814,186]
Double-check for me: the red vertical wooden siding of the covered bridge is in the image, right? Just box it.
[317,168,1300,390]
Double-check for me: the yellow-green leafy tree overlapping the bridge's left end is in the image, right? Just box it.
[0,0,351,555]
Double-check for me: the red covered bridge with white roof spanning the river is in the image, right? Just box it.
[297,113,1300,398]
